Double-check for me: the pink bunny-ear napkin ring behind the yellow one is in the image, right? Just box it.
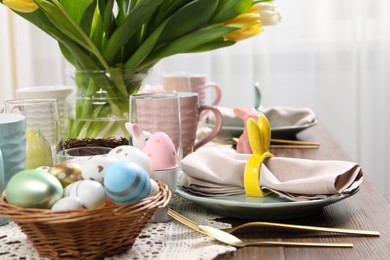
[233,107,262,154]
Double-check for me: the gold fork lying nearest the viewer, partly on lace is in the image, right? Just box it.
[168,209,353,247]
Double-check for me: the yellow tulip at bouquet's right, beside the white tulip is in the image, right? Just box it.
[224,8,263,41]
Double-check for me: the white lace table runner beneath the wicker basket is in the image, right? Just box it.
[0,196,236,260]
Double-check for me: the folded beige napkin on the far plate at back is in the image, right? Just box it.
[205,106,316,128]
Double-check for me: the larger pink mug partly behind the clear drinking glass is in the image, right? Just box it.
[130,92,223,158]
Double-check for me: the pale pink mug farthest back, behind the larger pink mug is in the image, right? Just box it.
[163,74,222,106]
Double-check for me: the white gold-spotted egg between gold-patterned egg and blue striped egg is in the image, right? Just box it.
[81,155,118,184]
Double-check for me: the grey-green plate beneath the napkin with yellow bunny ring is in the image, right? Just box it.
[176,186,359,220]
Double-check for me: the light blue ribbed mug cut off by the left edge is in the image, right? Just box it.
[0,114,26,226]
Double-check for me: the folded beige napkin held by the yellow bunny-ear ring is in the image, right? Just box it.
[181,147,363,201]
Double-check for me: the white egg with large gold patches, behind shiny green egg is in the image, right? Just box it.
[48,161,82,187]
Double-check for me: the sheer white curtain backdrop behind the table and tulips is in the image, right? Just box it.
[0,0,390,201]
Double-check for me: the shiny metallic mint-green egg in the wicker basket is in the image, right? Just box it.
[6,169,64,209]
